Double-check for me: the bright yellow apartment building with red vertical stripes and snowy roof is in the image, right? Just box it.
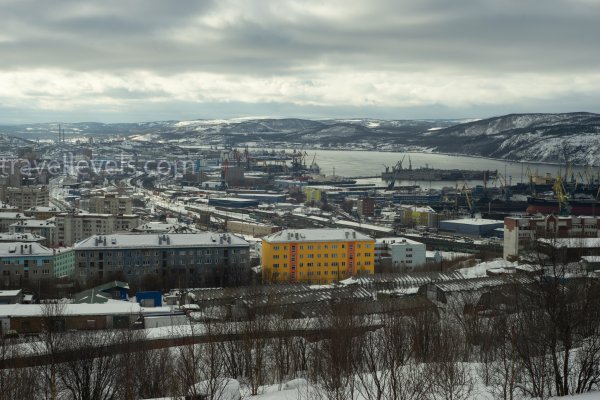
[262,229,375,284]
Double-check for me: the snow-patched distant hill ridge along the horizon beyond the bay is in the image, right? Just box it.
[0,112,600,165]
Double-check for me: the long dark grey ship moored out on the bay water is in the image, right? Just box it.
[381,158,498,181]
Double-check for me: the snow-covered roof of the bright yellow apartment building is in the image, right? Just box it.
[263,229,373,243]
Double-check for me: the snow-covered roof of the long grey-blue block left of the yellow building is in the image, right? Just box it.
[73,232,249,250]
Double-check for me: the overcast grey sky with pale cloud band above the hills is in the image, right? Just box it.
[0,0,600,123]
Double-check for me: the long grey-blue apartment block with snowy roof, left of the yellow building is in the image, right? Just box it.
[73,232,250,287]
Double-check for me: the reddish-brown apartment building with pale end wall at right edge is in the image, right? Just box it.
[504,214,600,258]
